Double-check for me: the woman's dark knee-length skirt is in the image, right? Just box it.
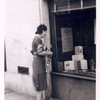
[32,57,47,91]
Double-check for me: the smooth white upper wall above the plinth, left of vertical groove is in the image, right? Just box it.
[5,0,40,74]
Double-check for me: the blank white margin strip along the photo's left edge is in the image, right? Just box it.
[0,0,5,97]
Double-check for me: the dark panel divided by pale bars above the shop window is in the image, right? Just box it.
[54,0,96,11]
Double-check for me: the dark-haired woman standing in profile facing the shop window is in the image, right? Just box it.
[32,24,53,100]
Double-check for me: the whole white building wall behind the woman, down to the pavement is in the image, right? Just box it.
[5,0,50,96]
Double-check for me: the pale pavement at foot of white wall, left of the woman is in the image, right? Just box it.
[4,89,36,100]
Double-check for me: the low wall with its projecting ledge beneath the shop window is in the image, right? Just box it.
[51,72,96,100]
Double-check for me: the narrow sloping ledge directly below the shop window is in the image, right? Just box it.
[51,72,96,81]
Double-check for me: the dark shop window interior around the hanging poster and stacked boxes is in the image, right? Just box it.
[56,8,96,69]
